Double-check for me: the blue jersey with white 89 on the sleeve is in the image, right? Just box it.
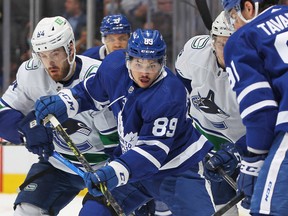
[72,50,212,181]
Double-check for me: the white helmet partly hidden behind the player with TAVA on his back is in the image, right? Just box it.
[211,11,234,37]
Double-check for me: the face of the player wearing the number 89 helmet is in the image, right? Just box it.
[129,58,162,88]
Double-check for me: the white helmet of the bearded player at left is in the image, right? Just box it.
[31,16,75,56]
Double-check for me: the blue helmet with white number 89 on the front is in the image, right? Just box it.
[127,29,166,59]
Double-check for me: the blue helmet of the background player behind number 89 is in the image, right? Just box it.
[100,14,131,37]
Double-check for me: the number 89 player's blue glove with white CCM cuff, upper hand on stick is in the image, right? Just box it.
[35,89,79,124]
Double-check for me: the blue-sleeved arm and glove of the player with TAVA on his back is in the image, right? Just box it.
[224,33,278,209]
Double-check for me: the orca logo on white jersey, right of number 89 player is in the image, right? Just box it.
[191,90,230,129]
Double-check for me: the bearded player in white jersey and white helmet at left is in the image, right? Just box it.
[0,17,118,216]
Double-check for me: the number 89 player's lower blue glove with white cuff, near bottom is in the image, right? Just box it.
[84,160,129,197]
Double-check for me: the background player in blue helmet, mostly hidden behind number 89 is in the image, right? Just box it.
[83,14,131,61]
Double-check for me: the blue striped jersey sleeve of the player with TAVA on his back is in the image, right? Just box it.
[224,25,278,153]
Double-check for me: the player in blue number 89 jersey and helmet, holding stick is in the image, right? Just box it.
[35,29,214,216]
